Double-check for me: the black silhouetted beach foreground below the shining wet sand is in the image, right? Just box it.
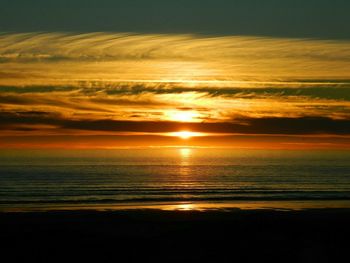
[0,209,350,262]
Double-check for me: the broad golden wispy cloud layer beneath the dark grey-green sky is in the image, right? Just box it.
[0,33,350,85]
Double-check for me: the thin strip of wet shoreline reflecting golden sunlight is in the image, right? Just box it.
[0,200,350,213]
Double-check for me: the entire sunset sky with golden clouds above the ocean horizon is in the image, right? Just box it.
[0,0,350,148]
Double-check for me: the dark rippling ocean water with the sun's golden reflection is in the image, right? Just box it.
[0,148,350,210]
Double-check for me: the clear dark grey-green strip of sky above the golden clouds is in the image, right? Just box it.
[0,0,350,39]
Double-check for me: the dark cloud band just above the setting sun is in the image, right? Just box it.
[0,112,350,135]
